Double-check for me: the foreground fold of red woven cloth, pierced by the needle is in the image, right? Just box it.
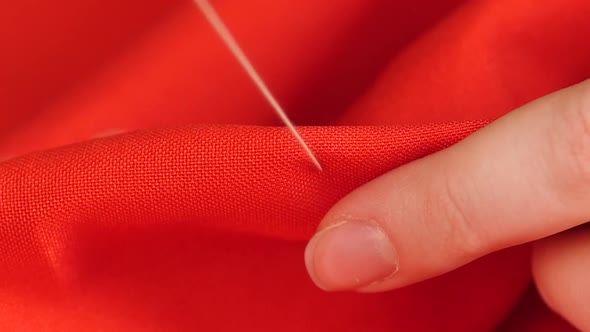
[0,122,528,331]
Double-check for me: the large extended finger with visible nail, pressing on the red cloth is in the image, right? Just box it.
[306,81,590,291]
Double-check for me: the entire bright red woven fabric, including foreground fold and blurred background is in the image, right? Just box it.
[0,0,590,331]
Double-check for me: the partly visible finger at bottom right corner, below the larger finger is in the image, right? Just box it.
[533,227,590,332]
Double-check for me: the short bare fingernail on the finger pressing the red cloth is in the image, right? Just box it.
[305,222,398,291]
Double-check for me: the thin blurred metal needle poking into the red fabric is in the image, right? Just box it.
[194,0,322,171]
